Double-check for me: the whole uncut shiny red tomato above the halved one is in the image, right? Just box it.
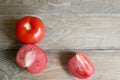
[15,16,45,44]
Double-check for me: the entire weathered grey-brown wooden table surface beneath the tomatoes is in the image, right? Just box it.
[0,0,120,80]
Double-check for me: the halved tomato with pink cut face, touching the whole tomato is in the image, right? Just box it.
[16,44,47,74]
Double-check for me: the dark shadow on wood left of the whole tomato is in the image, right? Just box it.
[2,16,22,49]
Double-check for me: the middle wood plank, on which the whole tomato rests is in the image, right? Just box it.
[0,14,120,49]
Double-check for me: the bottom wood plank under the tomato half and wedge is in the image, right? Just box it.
[0,50,120,80]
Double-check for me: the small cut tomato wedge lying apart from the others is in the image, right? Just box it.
[68,52,94,79]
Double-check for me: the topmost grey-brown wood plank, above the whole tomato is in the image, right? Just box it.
[0,0,120,16]
